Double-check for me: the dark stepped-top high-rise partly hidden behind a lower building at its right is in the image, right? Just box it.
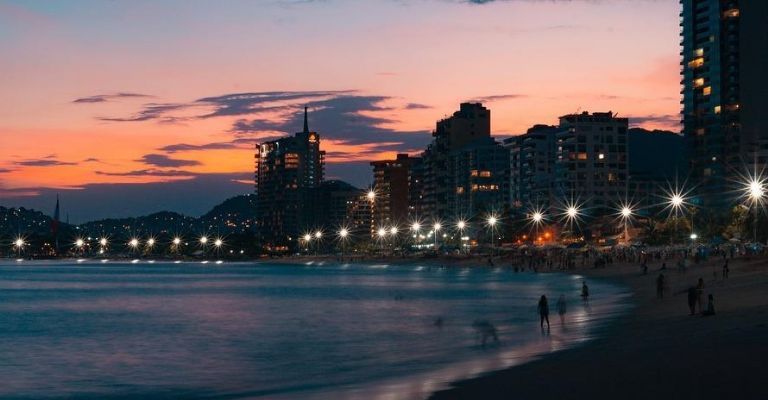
[420,103,491,220]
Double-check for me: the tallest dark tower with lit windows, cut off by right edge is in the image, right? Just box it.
[680,0,768,206]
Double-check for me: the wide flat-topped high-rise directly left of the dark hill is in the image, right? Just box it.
[553,111,629,215]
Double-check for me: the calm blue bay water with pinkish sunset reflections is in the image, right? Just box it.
[0,261,626,399]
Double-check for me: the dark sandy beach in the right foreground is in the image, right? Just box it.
[431,258,768,400]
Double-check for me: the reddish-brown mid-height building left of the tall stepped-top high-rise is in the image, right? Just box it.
[371,154,414,227]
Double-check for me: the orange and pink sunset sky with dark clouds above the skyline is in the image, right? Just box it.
[0,0,680,222]
